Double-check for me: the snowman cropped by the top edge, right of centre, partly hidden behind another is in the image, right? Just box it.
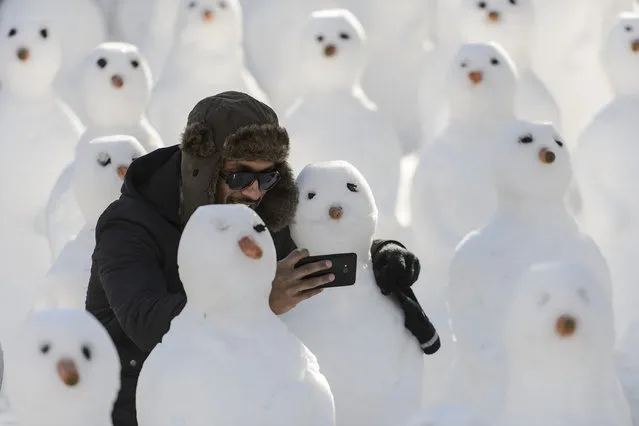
[459,0,561,135]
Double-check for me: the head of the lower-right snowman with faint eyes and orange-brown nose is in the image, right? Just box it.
[502,262,615,369]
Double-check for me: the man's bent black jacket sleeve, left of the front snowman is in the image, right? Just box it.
[96,221,186,352]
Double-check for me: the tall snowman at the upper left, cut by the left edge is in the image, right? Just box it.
[0,19,82,340]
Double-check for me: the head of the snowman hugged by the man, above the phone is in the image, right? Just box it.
[291,161,378,259]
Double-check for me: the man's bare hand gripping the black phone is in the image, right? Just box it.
[269,250,335,315]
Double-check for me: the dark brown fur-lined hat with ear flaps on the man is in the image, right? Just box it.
[180,92,298,231]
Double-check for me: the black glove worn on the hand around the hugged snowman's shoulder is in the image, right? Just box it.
[371,240,420,295]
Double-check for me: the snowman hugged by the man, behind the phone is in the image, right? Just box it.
[281,161,428,426]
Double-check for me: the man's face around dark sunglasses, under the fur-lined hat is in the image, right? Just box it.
[215,160,275,209]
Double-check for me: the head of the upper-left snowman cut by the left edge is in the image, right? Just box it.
[0,19,62,96]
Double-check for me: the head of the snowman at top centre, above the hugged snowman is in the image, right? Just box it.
[300,9,366,91]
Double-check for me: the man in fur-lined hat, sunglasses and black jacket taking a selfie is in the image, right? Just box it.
[86,92,436,426]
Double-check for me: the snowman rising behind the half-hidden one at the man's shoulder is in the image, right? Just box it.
[45,42,163,258]
